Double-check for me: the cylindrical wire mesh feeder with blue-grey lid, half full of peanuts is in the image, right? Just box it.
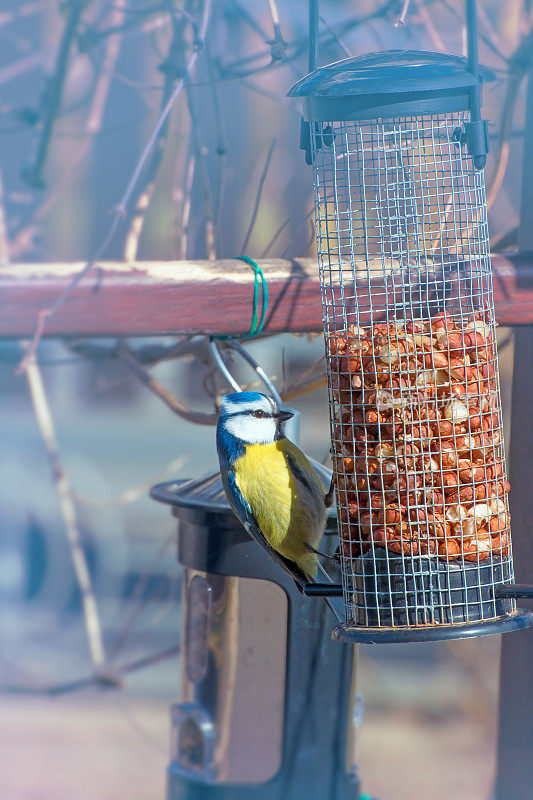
[290,3,531,642]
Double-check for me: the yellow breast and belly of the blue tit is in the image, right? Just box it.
[233,439,326,564]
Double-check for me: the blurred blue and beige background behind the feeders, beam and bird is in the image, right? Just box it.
[0,0,533,800]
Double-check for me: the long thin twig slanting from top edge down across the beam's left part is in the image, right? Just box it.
[16,0,211,375]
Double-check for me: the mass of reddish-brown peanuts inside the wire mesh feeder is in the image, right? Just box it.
[326,312,509,561]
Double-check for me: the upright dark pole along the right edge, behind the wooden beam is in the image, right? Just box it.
[495,69,533,800]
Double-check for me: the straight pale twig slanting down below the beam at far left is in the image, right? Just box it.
[26,348,105,672]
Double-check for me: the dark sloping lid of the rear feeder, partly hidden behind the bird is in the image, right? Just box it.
[150,458,336,527]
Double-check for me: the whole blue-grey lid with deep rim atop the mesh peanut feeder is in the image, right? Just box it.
[288,50,494,121]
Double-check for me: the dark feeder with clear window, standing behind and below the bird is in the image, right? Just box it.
[152,462,359,800]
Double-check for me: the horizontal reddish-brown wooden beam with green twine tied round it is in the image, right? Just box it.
[0,253,533,337]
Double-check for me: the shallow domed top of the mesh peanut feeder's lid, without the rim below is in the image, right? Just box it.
[288,50,495,97]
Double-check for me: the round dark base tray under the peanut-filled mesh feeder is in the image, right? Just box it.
[331,609,533,644]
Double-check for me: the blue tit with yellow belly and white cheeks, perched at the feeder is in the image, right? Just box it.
[217,392,327,585]
